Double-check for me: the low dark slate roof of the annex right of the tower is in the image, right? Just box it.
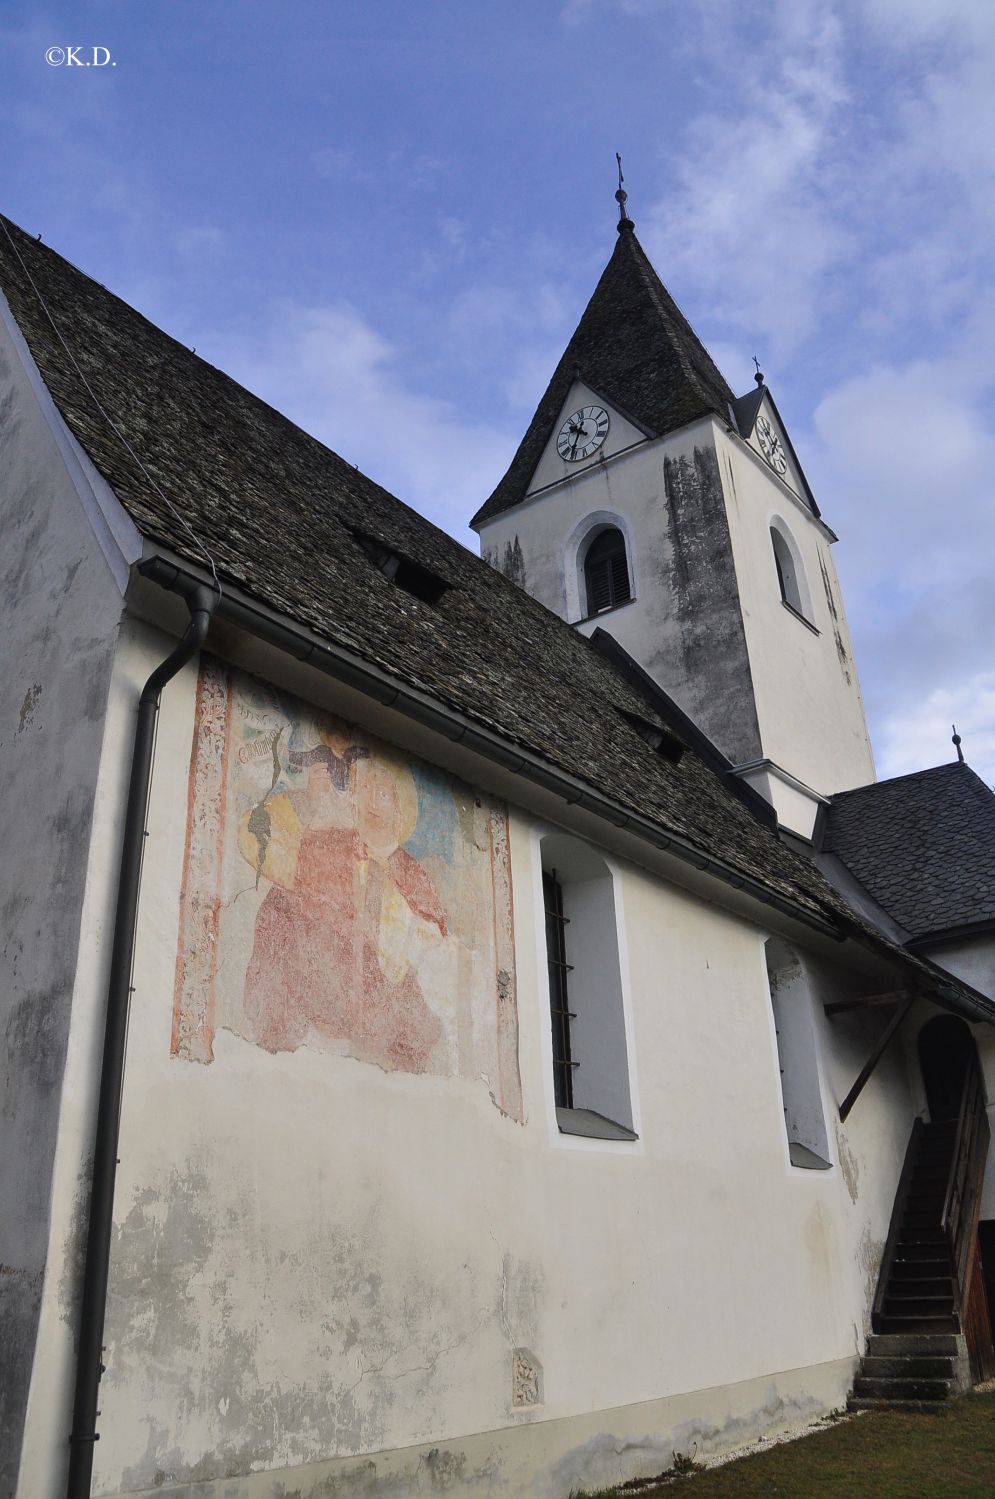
[823,760,995,937]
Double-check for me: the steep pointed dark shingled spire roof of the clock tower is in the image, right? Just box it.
[471,220,734,526]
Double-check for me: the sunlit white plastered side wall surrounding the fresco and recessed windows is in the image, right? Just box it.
[21,625,911,1499]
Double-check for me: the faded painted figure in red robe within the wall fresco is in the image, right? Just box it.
[238,726,447,1072]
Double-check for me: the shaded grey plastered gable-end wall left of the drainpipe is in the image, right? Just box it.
[0,297,139,1495]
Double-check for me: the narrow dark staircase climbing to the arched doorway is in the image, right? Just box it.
[848,1120,971,1411]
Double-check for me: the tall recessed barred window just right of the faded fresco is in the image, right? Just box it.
[542,833,637,1139]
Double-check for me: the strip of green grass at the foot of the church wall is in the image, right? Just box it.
[575,1393,995,1499]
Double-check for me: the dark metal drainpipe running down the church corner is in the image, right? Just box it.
[66,586,219,1499]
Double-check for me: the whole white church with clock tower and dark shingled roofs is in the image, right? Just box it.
[0,196,995,1499]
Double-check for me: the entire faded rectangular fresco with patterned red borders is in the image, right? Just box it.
[172,657,521,1120]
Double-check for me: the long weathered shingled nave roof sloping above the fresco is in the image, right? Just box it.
[0,220,989,1019]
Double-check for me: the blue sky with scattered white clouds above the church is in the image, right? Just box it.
[0,0,995,782]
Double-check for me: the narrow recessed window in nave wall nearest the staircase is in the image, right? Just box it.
[764,938,832,1171]
